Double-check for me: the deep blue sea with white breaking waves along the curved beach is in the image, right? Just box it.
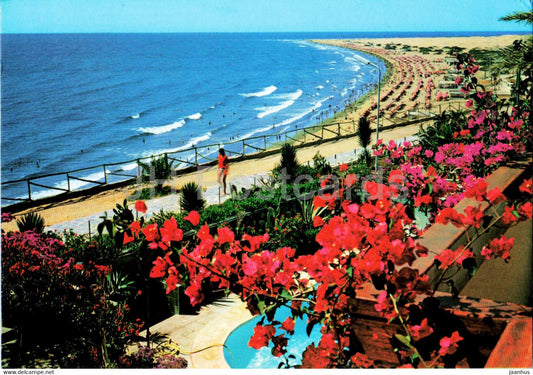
[1,33,524,205]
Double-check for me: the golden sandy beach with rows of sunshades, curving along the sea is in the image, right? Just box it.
[2,35,520,230]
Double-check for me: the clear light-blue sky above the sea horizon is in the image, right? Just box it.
[0,0,531,33]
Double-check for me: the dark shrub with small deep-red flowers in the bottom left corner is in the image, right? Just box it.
[2,232,139,368]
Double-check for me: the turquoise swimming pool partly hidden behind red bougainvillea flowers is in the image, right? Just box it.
[224,306,321,369]
